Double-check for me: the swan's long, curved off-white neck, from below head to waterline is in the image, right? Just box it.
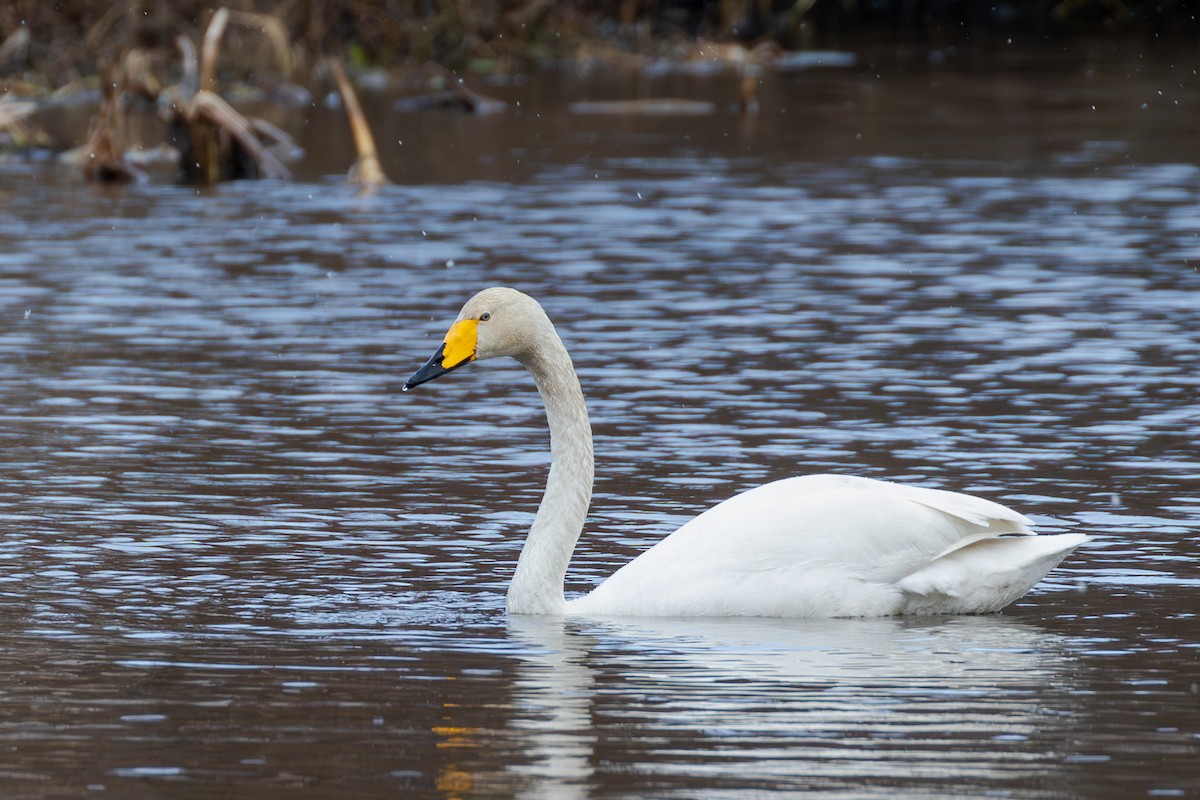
[508,328,595,614]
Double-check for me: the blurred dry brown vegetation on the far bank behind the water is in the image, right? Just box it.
[0,0,1200,88]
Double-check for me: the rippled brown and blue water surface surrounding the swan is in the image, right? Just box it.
[0,42,1200,800]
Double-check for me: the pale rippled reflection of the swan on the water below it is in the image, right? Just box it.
[509,616,1068,798]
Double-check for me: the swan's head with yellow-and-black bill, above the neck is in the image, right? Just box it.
[404,287,554,391]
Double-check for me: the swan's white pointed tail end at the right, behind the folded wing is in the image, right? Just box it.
[896,534,1090,614]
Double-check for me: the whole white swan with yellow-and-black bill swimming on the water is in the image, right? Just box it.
[404,288,1088,616]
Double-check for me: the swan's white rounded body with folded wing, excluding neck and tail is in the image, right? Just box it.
[569,475,1089,616]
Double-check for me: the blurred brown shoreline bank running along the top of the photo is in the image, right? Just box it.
[0,0,1200,97]
